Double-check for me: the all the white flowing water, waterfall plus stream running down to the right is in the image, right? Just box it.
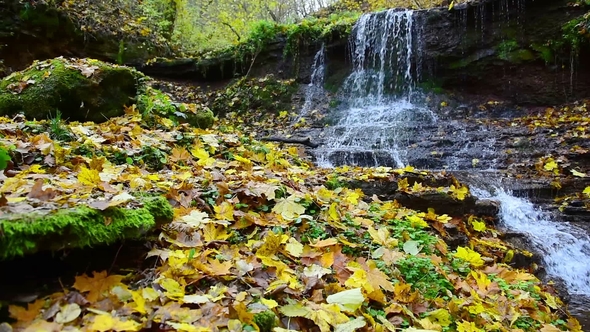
[305,6,590,330]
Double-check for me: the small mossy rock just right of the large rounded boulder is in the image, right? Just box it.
[137,87,215,129]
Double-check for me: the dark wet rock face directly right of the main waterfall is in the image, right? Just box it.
[416,0,590,105]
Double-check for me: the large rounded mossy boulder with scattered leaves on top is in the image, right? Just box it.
[0,57,141,122]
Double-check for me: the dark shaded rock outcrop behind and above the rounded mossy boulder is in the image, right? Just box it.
[0,0,172,75]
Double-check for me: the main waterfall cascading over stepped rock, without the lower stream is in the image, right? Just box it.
[315,10,434,167]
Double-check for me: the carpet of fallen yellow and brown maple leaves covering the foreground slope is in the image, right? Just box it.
[0,107,581,332]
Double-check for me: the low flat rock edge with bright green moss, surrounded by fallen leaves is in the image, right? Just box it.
[0,197,174,260]
